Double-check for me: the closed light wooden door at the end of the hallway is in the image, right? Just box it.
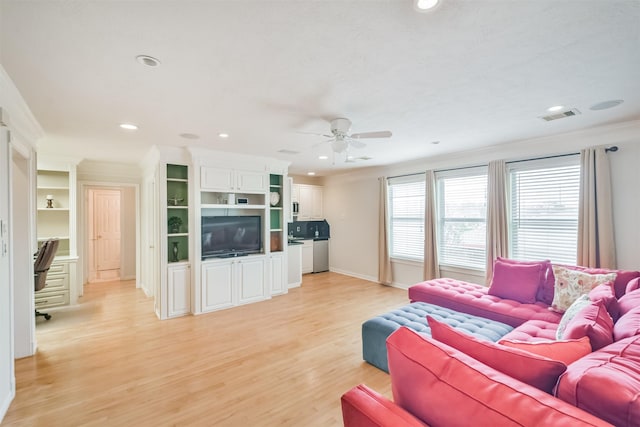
[87,187,122,283]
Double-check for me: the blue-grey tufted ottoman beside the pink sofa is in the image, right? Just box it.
[362,302,513,372]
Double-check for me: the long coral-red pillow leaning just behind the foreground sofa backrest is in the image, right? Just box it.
[427,316,567,393]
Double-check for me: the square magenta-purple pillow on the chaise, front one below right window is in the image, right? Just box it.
[488,260,542,304]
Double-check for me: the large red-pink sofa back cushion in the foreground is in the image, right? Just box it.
[387,327,608,427]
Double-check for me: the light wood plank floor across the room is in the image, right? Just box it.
[2,273,408,426]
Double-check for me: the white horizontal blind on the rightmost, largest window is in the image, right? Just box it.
[508,155,580,265]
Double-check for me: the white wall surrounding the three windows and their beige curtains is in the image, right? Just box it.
[324,121,640,287]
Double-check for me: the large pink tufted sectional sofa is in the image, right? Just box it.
[342,261,640,426]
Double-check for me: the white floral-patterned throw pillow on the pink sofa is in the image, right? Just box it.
[550,265,616,313]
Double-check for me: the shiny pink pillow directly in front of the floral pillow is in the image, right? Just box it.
[562,301,613,351]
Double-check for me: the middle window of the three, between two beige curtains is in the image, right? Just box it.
[436,167,487,270]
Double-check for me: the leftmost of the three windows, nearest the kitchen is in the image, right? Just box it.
[387,174,425,261]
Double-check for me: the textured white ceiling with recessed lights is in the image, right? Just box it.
[0,0,640,175]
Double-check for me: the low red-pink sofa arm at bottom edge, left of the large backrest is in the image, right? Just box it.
[340,384,427,427]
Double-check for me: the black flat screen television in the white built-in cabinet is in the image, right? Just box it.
[202,216,262,259]
